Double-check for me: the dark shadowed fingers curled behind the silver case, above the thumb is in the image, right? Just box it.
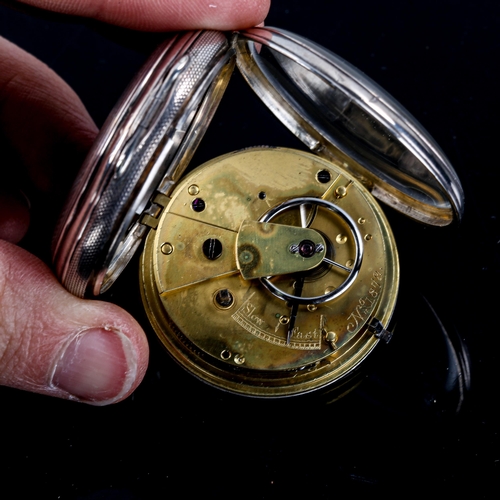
[0,37,97,243]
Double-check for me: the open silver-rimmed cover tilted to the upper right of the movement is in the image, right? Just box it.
[235,27,464,226]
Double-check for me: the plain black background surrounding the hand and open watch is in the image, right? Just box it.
[0,0,500,499]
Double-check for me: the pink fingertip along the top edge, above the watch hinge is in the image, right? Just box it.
[18,0,270,31]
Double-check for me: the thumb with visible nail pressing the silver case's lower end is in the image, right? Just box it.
[0,240,149,405]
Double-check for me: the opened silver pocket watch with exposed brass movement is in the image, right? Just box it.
[54,28,463,398]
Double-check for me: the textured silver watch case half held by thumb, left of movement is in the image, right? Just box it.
[53,31,234,297]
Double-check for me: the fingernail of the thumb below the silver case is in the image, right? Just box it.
[52,329,137,405]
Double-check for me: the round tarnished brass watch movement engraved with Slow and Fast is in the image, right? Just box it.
[141,148,399,397]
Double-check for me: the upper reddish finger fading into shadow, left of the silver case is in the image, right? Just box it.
[0,37,98,192]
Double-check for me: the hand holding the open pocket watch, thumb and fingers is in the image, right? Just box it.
[0,0,269,405]
